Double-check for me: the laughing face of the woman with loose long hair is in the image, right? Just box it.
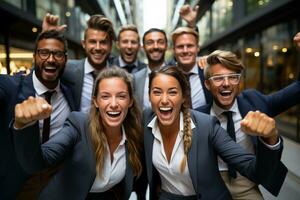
[94,77,133,131]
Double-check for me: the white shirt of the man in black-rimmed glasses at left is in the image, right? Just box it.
[32,72,71,138]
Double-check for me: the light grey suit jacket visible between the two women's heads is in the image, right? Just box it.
[133,68,148,110]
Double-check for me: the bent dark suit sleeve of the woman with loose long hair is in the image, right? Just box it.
[10,114,82,173]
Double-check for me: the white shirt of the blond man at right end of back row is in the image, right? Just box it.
[188,64,206,108]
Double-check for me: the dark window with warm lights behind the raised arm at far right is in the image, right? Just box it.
[262,21,300,141]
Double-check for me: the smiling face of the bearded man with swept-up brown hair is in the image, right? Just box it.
[81,28,112,70]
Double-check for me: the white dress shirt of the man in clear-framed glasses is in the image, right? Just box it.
[210,99,281,171]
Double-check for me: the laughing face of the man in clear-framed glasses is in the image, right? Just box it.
[205,64,239,110]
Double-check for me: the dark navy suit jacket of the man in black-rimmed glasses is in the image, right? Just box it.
[0,72,75,199]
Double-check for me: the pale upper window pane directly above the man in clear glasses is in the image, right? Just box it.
[212,0,233,34]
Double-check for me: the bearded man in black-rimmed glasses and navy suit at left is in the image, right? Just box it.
[0,31,75,199]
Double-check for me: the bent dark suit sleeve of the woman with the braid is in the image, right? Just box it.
[212,117,282,184]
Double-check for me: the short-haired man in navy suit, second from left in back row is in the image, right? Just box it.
[111,25,147,73]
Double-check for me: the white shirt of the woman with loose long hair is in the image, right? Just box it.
[90,127,126,192]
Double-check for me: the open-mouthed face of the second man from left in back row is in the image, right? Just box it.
[117,30,140,64]
